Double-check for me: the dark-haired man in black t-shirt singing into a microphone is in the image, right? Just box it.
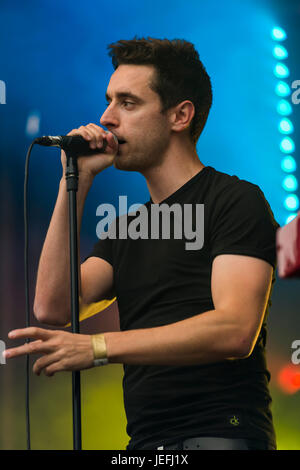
[6,38,279,450]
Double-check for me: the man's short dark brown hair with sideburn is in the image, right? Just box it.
[108,37,212,145]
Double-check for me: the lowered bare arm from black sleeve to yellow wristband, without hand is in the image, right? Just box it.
[104,255,273,365]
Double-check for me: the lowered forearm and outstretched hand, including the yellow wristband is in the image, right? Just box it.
[5,310,251,375]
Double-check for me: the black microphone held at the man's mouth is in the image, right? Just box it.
[34,135,108,156]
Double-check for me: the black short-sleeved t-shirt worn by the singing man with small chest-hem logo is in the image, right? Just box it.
[89,166,279,450]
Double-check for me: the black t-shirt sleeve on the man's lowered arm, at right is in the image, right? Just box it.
[210,181,279,269]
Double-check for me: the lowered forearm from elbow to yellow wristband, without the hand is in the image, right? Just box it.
[104,310,248,365]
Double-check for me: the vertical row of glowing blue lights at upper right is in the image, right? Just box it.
[271,27,299,224]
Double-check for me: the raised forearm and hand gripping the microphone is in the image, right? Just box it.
[34,124,117,326]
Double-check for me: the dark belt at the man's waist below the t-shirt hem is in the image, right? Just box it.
[156,437,275,450]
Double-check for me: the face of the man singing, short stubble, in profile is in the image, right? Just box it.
[100,65,170,173]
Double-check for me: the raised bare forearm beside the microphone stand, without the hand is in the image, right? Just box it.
[34,171,92,325]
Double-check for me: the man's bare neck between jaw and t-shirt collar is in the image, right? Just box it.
[143,136,205,204]
